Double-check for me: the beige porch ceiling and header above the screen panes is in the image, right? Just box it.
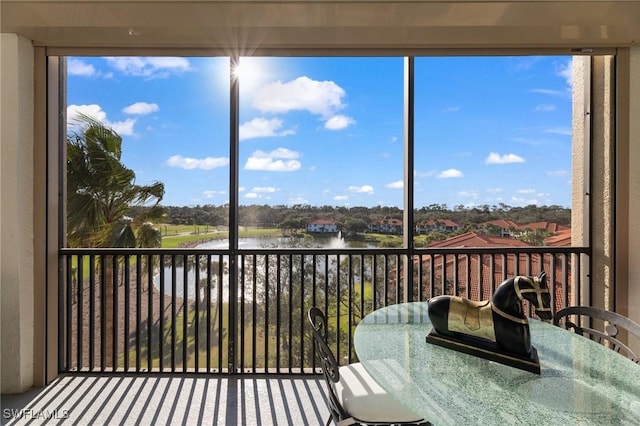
[0,0,640,53]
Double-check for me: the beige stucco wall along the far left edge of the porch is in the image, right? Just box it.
[0,34,34,393]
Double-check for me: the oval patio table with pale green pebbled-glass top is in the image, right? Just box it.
[354,302,640,425]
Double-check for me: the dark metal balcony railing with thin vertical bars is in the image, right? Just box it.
[58,247,589,374]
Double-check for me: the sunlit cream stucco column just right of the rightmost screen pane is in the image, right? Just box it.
[569,56,615,309]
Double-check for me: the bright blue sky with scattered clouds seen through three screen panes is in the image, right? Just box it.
[67,56,571,208]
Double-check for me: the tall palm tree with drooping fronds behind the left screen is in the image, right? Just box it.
[67,115,164,366]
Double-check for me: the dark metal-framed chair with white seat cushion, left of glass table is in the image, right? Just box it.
[308,307,431,426]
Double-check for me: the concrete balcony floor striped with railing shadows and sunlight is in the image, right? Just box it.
[2,374,329,426]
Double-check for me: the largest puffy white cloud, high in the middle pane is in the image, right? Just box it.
[253,76,345,117]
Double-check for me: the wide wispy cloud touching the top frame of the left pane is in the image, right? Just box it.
[105,56,191,78]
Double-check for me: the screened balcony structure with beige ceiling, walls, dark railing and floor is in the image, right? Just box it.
[1,0,640,424]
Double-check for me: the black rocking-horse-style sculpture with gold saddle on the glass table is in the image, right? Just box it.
[427,271,552,374]
